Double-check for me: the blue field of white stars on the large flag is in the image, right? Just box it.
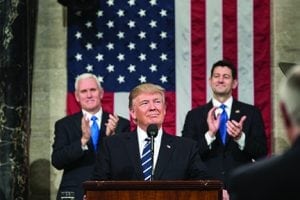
[71,0,174,89]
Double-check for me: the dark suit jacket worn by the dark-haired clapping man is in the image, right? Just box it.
[182,100,267,186]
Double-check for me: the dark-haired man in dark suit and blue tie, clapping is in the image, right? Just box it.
[182,60,267,192]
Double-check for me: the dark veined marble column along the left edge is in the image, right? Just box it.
[0,0,36,200]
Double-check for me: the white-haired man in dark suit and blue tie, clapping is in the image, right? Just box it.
[52,73,130,199]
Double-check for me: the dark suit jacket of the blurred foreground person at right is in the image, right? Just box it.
[228,138,300,200]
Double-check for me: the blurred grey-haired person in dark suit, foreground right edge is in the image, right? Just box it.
[228,66,300,200]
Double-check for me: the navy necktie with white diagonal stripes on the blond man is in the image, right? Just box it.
[141,138,152,181]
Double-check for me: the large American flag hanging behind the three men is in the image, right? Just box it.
[67,0,271,149]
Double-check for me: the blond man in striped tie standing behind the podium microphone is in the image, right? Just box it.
[94,83,209,180]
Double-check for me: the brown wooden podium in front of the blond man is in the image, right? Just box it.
[83,180,222,200]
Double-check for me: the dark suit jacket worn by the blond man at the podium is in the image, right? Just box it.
[93,131,210,180]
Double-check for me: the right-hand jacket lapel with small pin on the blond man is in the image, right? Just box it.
[154,133,176,180]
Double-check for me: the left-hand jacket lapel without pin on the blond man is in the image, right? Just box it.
[125,131,144,180]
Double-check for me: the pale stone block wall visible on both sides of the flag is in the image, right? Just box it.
[30,0,300,199]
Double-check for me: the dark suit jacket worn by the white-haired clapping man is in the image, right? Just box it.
[52,112,130,199]
